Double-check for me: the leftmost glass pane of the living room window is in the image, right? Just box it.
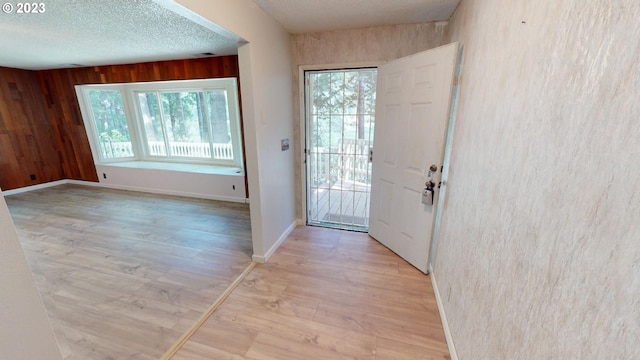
[89,90,134,159]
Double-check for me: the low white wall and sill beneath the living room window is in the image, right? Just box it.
[96,162,246,203]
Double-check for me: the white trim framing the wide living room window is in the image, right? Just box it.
[75,78,243,169]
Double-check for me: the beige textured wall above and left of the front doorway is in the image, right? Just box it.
[291,22,446,219]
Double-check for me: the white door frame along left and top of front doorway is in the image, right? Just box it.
[298,61,386,225]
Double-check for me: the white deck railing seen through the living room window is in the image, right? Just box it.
[100,141,233,160]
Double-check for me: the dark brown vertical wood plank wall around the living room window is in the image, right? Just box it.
[0,56,242,190]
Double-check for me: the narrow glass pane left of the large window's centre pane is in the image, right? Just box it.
[138,92,167,156]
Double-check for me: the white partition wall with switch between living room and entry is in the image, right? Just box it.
[177,0,296,261]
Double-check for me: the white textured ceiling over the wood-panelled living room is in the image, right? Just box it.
[0,0,239,70]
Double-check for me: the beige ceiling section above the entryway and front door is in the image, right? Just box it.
[255,0,460,33]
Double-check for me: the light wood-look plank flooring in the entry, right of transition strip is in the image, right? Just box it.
[173,227,450,360]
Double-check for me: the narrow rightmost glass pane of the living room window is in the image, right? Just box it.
[207,90,233,160]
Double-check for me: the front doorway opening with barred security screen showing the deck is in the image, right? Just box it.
[305,68,377,232]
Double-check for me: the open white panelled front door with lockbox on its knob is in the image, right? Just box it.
[369,43,458,272]
